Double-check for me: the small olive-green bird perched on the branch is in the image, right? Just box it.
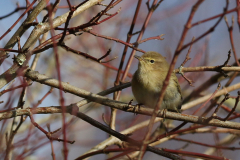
[132,51,182,113]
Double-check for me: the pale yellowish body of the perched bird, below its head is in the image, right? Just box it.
[132,71,181,111]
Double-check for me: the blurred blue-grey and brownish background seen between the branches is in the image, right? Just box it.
[0,0,240,160]
